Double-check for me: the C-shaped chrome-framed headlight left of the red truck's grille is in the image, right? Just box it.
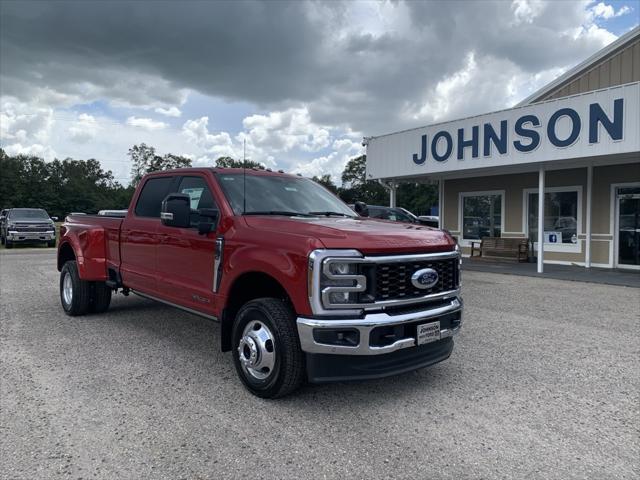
[308,250,367,314]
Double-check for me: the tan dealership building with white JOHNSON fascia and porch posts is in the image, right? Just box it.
[365,27,640,271]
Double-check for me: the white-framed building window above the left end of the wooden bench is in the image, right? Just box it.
[461,192,504,240]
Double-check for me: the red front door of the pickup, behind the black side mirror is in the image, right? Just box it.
[156,174,219,314]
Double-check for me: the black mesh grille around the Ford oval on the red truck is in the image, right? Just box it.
[376,258,458,301]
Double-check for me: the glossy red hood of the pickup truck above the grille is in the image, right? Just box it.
[244,216,455,254]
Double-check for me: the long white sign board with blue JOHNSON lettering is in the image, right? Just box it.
[367,82,640,179]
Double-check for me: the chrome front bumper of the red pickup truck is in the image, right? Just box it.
[297,298,462,355]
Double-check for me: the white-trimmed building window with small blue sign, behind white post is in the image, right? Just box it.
[527,187,582,252]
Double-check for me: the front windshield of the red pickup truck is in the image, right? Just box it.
[218,173,356,217]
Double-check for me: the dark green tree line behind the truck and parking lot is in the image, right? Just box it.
[0,143,437,218]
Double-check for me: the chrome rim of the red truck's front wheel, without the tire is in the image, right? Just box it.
[238,320,276,380]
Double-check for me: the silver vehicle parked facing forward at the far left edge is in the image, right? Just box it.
[0,208,56,248]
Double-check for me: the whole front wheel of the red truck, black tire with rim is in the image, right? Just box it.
[231,298,306,398]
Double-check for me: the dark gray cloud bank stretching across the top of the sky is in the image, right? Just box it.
[0,1,632,138]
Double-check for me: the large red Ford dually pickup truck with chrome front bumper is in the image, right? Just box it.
[58,168,462,398]
